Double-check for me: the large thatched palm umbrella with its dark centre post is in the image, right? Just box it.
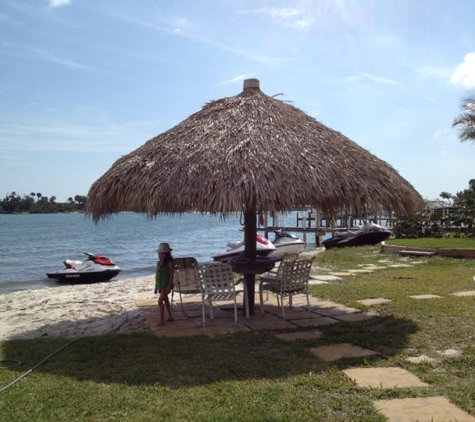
[86,79,423,308]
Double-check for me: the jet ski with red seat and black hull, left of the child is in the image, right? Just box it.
[46,252,121,283]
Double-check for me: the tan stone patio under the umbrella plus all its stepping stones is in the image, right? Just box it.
[136,259,475,422]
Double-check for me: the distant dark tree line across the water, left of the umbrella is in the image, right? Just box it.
[0,192,86,214]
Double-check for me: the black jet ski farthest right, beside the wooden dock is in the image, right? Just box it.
[322,223,392,249]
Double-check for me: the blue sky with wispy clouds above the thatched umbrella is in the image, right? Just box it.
[0,0,475,202]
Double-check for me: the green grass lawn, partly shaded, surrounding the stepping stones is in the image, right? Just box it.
[0,246,475,422]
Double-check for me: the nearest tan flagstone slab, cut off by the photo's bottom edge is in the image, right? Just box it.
[373,396,475,422]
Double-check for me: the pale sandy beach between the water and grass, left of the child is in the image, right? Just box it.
[0,275,156,341]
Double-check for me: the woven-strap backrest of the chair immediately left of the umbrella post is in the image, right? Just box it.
[196,262,235,294]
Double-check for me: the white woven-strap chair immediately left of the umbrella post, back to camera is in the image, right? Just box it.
[196,262,245,327]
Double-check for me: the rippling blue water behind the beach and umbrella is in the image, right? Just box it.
[0,213,308,294]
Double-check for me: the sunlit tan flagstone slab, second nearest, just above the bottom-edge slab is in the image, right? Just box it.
[343,367,428,388]
